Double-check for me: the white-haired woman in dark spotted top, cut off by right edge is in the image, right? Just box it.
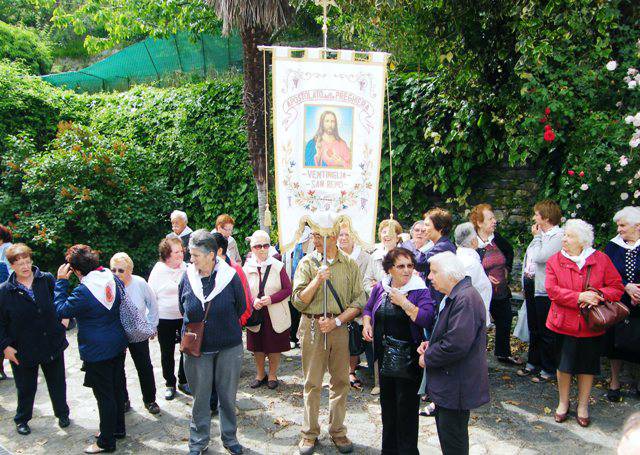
[604,206,640,402]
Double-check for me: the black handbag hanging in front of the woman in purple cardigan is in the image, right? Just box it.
[380,295,420,380]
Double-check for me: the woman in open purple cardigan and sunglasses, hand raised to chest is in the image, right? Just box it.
[362,248,435,454]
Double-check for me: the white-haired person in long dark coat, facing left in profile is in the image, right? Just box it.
[418,251,489,455]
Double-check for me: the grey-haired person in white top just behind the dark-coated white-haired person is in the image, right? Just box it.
[453,222,492,325]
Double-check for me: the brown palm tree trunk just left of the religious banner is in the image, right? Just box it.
[240,27,269,229]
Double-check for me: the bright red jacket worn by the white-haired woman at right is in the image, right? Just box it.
[545,251,624,338]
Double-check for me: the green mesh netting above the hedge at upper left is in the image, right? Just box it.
[42,33,242,92]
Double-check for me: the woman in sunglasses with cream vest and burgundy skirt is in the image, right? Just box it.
[243,231,292,389]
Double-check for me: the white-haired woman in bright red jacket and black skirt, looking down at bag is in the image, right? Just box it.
[545,220,624,427]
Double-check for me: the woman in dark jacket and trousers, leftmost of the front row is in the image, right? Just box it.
[0,243,70,435]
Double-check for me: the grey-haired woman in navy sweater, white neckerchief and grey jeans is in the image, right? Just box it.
[178,229,246,455]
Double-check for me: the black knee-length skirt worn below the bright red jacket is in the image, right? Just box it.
[556,334,602,375]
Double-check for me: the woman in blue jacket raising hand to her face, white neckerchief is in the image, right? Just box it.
[55,245,128,453]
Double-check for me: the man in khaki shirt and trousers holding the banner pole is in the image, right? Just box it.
[293,224,365,455]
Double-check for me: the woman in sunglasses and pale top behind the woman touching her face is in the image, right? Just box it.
[109,253,160,414]
